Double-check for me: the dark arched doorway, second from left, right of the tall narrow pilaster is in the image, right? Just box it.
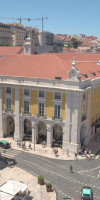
[23,119,32,141]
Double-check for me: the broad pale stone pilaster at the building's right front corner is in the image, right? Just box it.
[63,90,81,152]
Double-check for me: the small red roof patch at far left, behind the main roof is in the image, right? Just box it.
[0,46,22,56]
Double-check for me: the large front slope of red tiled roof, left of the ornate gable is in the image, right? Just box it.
[0,55,71,79]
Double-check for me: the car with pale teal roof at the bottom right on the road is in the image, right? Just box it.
[81,187,93,200]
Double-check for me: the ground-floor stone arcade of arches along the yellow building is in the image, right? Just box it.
[0,113,99,152]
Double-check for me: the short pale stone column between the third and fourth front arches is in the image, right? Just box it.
[47,125,53,146]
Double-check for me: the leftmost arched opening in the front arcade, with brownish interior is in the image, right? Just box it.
[6,116,15,137]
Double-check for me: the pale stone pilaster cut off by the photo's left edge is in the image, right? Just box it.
[0,86,3,137]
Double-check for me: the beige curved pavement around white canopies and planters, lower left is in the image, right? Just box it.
[0,161,56,200]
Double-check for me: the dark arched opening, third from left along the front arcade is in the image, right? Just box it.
[37,121,47,144]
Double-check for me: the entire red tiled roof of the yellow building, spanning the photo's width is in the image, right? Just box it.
[0,53,100,80]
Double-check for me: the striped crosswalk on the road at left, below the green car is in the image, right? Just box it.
[0,148,21,158]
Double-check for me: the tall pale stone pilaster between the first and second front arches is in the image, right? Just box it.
[14,88,20,141]
